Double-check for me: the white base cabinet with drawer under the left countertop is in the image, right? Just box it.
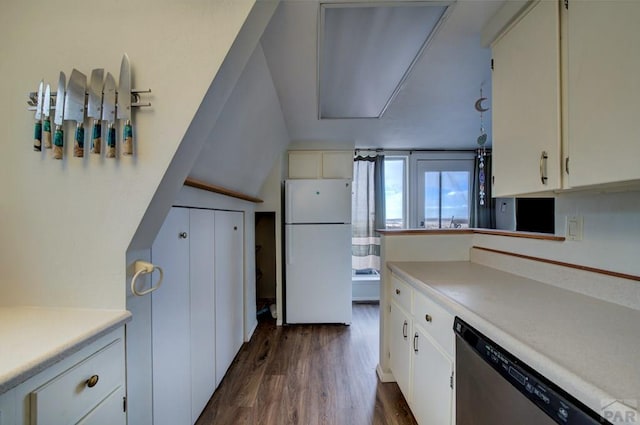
[11,327,127,425]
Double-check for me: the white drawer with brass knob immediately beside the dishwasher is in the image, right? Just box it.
[413,292,454,358]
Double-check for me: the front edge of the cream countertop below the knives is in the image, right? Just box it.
[0,310,132,394]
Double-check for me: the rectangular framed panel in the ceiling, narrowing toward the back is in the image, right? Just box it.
[318,2,450,119]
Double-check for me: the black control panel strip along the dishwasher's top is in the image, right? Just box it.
[453,317,611,425]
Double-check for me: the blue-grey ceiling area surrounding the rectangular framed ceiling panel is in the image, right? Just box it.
[261,0,503,149]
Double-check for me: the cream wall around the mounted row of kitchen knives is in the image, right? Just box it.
[0,0,254,309]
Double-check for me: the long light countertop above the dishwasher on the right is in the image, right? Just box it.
[388,261,640,412]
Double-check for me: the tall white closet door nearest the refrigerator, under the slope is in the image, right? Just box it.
[214,211,244,387]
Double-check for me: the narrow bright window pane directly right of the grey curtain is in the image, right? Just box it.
[384,156,407,229]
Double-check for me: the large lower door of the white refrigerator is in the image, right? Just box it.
[285,224,352,323]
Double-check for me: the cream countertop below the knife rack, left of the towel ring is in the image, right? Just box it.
[0,307,131,394]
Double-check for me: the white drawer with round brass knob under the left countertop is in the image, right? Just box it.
[30,338,124,425]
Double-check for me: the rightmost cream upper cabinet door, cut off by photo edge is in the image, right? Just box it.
[567,1,640,187]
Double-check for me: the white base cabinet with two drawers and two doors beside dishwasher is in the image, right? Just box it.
[389,275,455,425]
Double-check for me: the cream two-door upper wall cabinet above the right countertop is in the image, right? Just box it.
[492,0,640,196]
